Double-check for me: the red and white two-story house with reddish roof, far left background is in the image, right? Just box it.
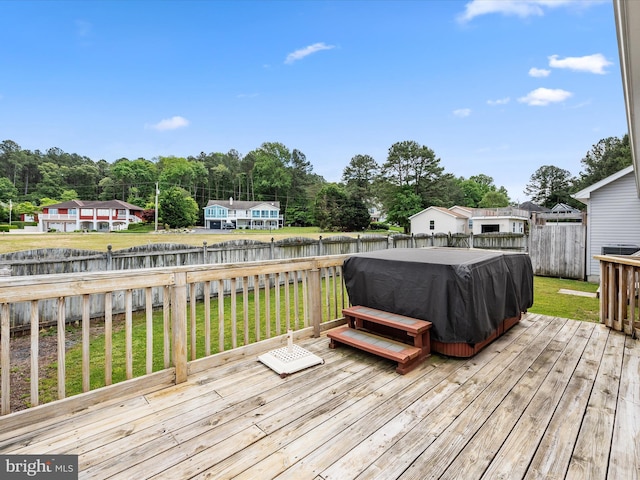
[38,200,144,232]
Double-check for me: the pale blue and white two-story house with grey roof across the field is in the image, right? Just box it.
[204,198,284,230]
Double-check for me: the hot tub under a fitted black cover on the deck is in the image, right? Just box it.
[343,248,533,357]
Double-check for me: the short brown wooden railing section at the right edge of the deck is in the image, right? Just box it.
[594,255,640,337]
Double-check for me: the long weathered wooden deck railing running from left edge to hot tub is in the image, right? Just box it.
[0,255,348,415]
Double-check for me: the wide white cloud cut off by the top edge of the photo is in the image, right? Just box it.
[458,0,605,23]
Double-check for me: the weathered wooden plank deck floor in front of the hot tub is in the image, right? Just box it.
[0,314,640,480]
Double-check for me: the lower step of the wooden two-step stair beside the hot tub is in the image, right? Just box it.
[327,325,424,375]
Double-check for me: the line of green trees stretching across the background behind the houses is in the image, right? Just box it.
[0,136,630,231]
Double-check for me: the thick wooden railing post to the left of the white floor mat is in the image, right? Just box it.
[171,272,187,384]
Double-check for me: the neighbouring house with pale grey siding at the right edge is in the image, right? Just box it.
[573,166,640,282]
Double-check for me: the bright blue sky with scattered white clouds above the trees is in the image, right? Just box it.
[0,0,627,201]
